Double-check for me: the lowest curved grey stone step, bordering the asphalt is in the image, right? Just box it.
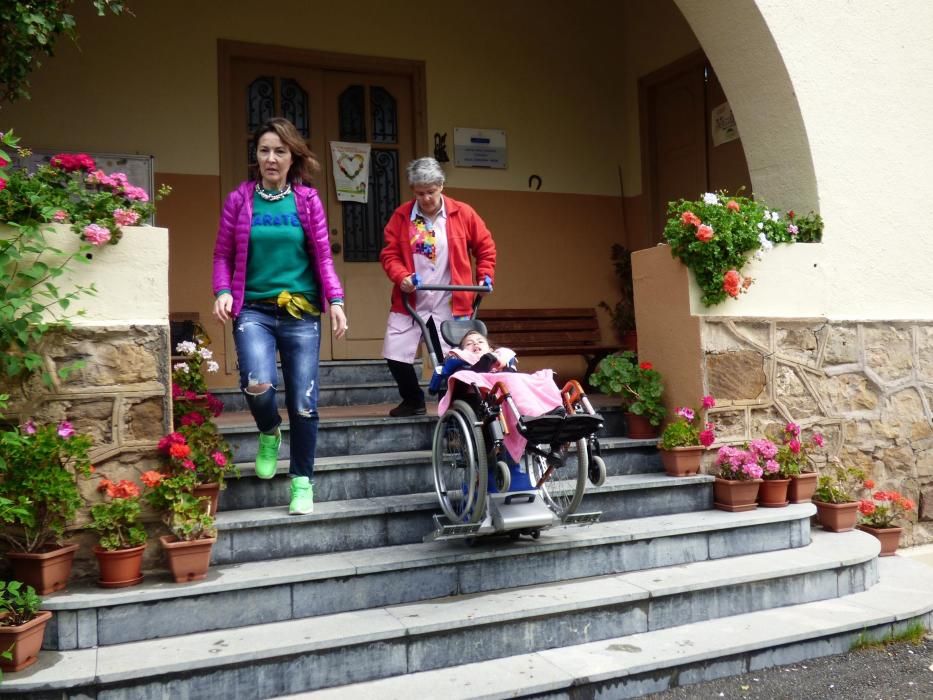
[290,557,933,700]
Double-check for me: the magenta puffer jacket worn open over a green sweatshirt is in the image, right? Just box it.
[214,181,343,316]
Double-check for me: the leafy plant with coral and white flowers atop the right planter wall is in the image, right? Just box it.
[664,192,822,306]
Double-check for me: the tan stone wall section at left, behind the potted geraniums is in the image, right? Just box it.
[6,325,172,577]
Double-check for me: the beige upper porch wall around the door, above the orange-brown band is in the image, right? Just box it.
[0,0,623,195]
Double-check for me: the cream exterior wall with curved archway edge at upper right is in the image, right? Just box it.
[677,0,933,319]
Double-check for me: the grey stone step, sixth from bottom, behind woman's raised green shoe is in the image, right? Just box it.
[217,404,625,462]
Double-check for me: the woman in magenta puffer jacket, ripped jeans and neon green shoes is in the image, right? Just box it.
[214,118,347,515]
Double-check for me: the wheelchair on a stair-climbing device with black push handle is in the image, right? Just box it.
[403,280,606,542]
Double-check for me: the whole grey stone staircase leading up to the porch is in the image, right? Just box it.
[0,362,933,700]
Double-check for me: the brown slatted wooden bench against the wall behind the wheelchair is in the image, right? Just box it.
[479,307,622,377]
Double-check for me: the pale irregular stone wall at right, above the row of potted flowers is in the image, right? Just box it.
[701,318,933,546]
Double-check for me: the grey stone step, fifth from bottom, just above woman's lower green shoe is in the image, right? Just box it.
[219,438,661,511]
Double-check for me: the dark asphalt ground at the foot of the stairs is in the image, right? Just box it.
[643,635,933,700]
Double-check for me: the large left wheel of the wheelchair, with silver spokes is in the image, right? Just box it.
[433,401,487,523]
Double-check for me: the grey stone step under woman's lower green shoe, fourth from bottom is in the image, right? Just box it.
[211,473,714,564]
